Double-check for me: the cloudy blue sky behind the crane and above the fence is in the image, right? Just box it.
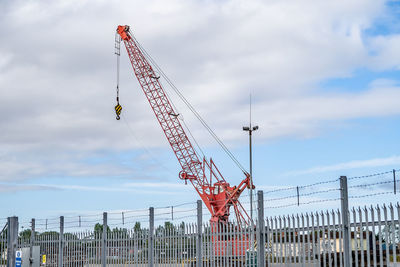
[0,0,400,230]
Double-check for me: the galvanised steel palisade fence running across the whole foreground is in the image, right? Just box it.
[0,177,400,267]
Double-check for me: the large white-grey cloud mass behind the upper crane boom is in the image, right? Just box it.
[0,0,400,183]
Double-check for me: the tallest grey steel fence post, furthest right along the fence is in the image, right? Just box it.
[340,176,351,267]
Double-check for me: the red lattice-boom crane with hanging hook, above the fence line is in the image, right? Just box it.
[115,25,250,226]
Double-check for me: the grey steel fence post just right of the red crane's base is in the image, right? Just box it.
[256,190,265,267]
